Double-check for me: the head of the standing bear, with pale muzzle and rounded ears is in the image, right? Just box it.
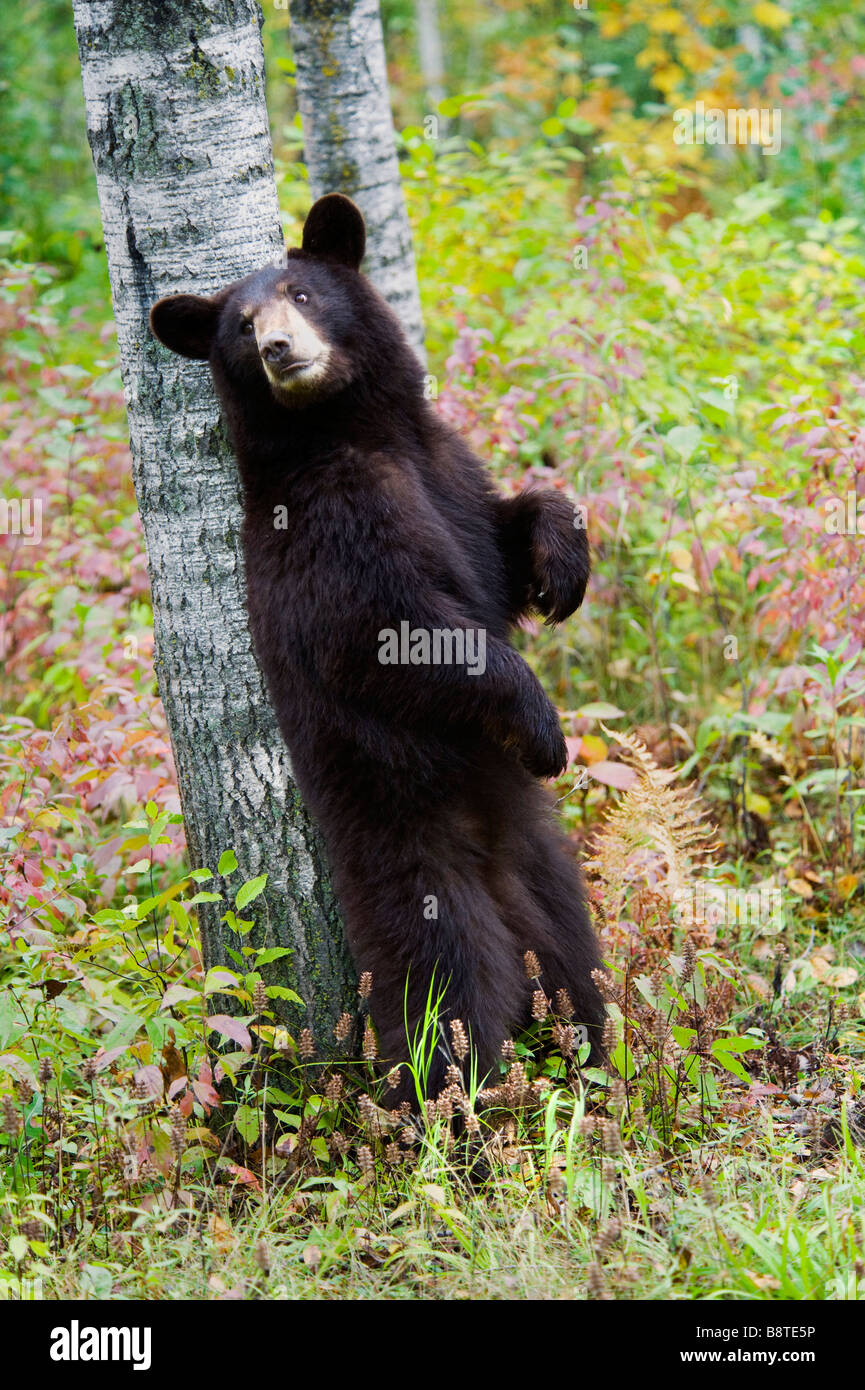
[150,193,405,410]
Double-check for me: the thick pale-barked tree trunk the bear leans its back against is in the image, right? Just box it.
[74,0,353,1047]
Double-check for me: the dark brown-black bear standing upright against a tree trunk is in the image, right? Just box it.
[150,193,604,1099]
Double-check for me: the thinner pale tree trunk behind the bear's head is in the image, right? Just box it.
[289,0,424,359]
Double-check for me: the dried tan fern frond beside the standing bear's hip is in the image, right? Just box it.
[585,724,716,920]
